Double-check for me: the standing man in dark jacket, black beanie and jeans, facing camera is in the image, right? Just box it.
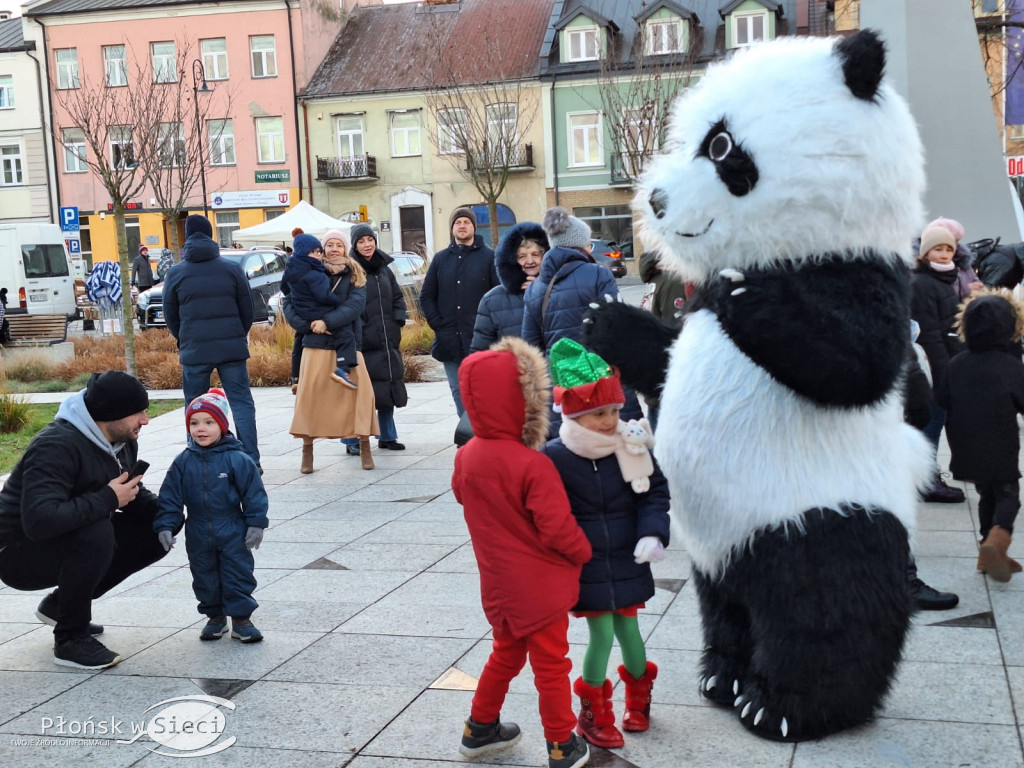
[420,208,499,417]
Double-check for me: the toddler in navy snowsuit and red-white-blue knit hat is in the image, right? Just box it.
[153,388,269,643]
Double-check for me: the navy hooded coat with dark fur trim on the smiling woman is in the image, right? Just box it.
[469,221,548,352]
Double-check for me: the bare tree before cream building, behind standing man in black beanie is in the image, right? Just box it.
[425,14,541,244]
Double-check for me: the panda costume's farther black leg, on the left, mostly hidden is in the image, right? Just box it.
[693,568,751,707]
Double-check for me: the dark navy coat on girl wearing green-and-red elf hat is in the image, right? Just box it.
[543,437,669,610]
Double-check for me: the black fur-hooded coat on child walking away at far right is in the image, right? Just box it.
[935,296,1024,483]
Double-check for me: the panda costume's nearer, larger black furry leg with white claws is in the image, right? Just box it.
[736,510,910,741]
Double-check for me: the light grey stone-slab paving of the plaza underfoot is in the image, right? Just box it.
[0,382,1024,768]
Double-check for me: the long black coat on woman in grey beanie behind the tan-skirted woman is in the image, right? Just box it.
[353,249,409,408]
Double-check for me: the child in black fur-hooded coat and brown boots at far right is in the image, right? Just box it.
[935,289,1024,582]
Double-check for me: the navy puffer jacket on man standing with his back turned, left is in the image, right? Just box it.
[164,233,253,366]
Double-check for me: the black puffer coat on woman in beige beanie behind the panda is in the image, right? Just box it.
[910,264,964,386]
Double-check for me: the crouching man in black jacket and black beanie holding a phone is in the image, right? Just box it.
[0,371,174,670]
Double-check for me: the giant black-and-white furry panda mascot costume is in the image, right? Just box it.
[585,31,932,741]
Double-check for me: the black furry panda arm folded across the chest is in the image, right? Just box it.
[709,256,910,408]
